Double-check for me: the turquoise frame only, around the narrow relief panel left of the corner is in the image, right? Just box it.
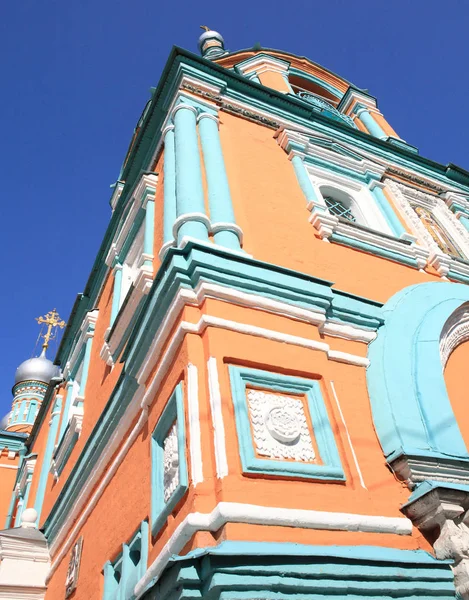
[151,383,189,535]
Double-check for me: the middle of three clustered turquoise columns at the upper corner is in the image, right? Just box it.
[173,104,208,242]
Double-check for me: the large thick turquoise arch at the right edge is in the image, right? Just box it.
[367,282,469,461]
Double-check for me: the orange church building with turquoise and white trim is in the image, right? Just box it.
[0,31,469,600]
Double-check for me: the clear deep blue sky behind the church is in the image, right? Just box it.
[0,0,469,413]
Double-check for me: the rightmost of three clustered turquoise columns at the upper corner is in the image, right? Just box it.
[199,113,241,250]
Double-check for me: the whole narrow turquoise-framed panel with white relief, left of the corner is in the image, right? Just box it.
[151,383,188,534]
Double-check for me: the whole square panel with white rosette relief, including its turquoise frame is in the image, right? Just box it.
[229,366,345,481]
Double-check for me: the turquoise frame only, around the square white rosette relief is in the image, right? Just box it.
[229,365,345,481]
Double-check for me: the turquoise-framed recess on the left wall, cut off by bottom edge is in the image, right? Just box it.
[103,521,148,600]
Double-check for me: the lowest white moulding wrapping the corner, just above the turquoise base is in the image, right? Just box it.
[134,502,412,599]
